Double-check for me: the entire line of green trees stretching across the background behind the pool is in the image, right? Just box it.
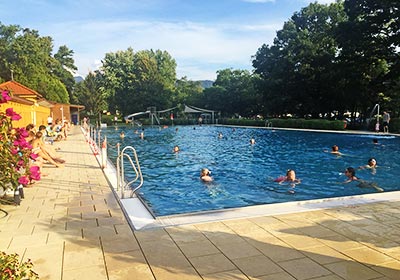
[0,0,400,122]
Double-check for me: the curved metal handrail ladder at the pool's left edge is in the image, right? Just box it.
[117,145,143,198]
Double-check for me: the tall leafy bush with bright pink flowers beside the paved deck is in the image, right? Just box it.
[0,91,40,201]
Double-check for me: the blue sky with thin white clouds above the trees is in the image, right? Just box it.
[0,0,333,80]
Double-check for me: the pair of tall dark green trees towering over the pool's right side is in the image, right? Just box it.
[253,0,400,117]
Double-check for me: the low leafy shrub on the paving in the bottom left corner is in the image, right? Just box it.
[0,252,39,280]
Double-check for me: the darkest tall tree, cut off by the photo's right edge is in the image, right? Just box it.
[337,0,400,116]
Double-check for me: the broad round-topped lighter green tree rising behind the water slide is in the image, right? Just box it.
[100,48,176,114]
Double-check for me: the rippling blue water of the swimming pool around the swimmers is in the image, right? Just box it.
[102,126,400,216]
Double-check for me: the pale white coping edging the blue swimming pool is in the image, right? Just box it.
[91,126,400,230]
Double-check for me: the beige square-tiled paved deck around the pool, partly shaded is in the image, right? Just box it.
[0,127,400,280]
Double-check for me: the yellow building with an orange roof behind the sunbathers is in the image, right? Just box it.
[0,81,53,127]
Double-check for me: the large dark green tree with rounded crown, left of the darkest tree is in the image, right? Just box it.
[253,2,345,116]
